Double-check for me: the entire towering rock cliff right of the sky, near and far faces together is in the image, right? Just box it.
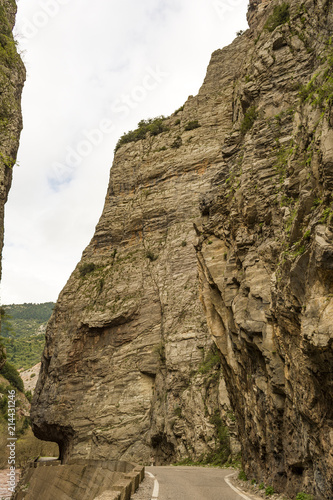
[32,0,333,499]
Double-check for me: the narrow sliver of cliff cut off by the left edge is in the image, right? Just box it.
[0,0,25,365]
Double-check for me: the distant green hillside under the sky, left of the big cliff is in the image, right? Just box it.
[1,302,54,370]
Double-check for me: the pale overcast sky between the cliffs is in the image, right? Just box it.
[1,0,248,304]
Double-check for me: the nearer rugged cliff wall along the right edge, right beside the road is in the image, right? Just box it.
[197,2,333,499]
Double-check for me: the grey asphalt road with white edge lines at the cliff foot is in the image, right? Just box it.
[146,467,250,500]
